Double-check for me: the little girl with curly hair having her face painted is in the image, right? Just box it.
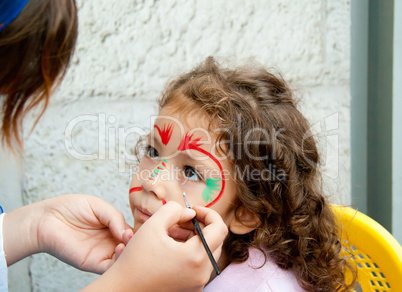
[129,57,353,292]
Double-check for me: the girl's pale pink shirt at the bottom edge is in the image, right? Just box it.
[203,248,305,292]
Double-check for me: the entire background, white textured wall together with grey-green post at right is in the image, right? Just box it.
[0,0,402,291]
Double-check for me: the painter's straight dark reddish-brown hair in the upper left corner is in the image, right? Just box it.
[0,0,78,149]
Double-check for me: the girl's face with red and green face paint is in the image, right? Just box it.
[129,107,236,232]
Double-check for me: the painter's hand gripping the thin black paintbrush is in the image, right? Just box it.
[83,202,227,292]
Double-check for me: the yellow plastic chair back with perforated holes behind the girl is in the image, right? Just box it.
[334,205,402,292]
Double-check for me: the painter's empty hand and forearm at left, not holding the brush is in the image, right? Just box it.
[3,195,129,273]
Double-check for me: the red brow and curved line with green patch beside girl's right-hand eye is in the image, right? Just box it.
[177,132,225,208]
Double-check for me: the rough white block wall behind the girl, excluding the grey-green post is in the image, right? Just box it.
[10,0,350,291]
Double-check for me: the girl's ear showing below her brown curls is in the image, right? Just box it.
[229,206,261,235]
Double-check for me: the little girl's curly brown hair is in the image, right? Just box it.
[159,57,355,292]
